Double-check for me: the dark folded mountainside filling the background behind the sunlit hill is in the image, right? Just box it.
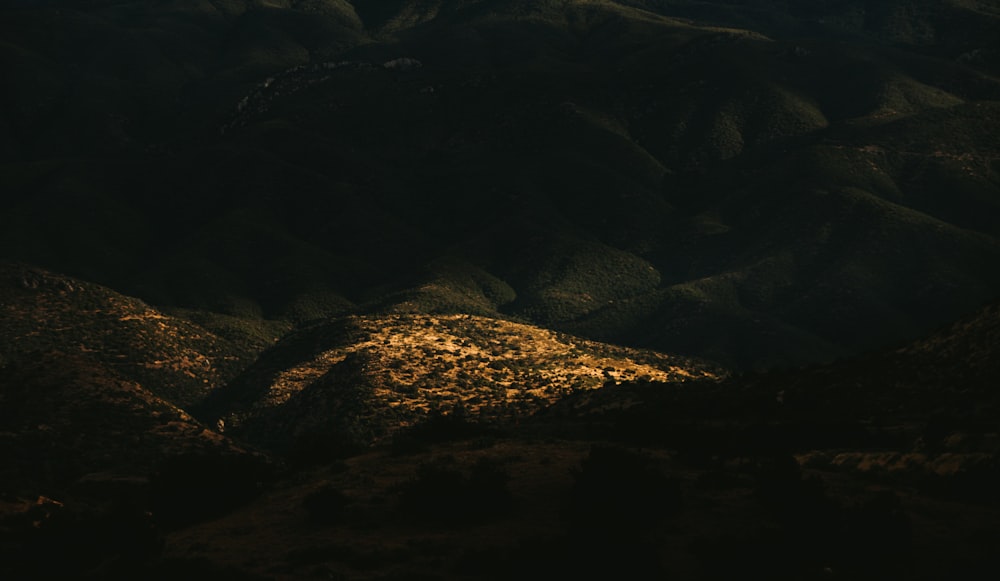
[0,0,1000,369]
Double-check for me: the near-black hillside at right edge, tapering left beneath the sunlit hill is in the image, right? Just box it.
[537,294,1000,448]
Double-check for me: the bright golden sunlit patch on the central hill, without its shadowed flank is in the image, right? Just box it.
[254,314,715,425]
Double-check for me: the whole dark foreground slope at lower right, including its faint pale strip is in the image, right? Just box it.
[156,304,1000,580]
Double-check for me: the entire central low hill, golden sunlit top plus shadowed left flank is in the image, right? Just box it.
[205,315,724,452]
